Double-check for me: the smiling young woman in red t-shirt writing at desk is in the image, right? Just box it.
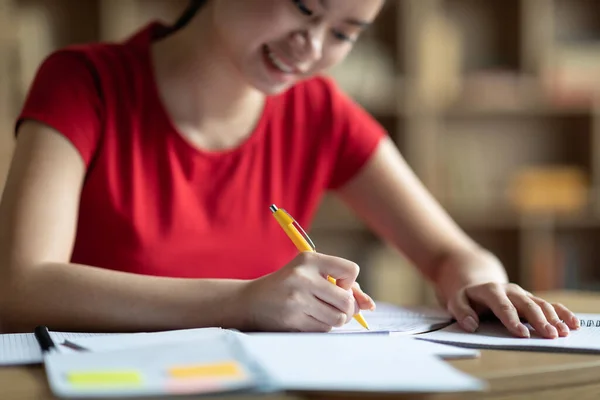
[0,0,578,338]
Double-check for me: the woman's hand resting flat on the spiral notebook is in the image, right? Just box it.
[446,283,579,338]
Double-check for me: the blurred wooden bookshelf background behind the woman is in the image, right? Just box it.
[0,0,600,304]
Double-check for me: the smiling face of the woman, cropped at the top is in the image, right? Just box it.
[212,0,385,94]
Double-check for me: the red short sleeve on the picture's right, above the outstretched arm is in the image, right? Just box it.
[327,79,387,189]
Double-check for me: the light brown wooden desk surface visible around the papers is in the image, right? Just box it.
[0,292,600,400]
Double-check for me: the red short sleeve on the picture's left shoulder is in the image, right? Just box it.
[15,50,102,167]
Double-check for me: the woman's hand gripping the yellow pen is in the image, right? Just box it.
[242,252,373,332]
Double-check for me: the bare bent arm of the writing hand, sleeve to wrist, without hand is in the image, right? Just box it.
[0,121,243,331]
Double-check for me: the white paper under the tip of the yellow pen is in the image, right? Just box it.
[330,303,452,335]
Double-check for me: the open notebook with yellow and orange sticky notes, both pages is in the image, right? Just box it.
[45,330,485,398]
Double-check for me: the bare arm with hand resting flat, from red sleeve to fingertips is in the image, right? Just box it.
[332,139,578,338]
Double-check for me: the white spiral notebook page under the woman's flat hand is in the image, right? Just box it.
[416,314,600,353]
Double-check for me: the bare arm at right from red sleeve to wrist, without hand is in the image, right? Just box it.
[338,138,505,280]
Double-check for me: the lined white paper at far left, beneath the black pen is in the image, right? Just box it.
[0,332,105,365]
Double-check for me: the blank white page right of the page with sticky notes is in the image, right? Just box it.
[243,333,485,392]
